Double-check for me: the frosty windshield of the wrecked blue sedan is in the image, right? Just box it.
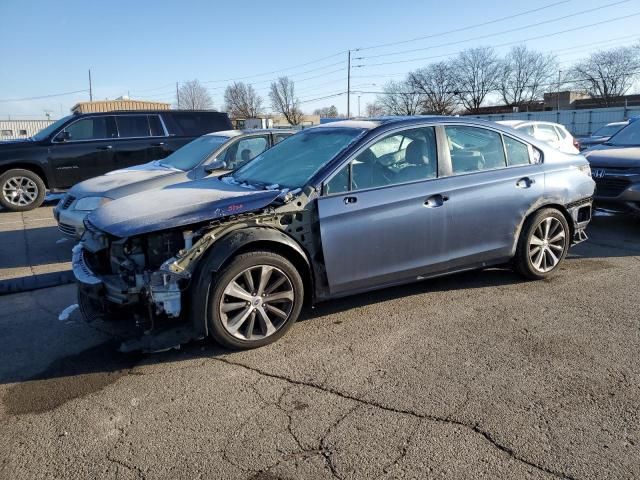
[232,127,365,189]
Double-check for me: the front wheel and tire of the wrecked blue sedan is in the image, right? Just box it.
[207,251,304,349]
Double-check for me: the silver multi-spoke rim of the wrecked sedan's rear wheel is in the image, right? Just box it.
[529,217,567,273]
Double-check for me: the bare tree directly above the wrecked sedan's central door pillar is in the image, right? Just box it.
[408,62,458,115]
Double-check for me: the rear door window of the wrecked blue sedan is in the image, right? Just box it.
[445,126,507,175]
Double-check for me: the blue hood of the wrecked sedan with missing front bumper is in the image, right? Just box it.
[87,178,282,238]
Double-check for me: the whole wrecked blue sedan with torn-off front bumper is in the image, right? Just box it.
[73,117,594,351]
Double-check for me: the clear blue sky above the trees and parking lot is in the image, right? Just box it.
[0,0,640,118]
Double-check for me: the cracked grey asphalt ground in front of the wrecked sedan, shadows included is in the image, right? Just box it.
[0,217,640,480]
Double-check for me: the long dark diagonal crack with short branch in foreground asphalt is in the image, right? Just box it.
[211,357,575,480]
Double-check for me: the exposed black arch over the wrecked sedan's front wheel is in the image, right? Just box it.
[190,227,315,336]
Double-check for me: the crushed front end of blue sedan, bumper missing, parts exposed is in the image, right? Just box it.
[72,222,197,350]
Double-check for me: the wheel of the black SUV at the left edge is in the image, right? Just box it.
[0,168,47,212]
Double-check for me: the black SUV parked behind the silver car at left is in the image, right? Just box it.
[0,110,232,212]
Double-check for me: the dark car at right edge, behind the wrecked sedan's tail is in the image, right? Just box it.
[584,120,640,217]
